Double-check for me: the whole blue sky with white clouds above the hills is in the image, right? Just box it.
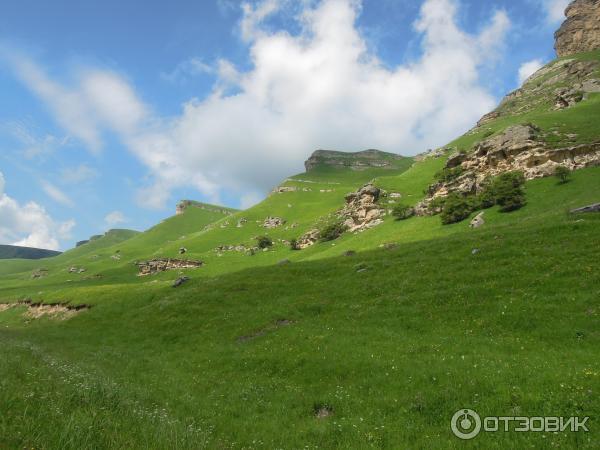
[0,0,568,249]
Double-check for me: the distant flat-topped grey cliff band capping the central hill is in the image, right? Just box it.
[304,149,404,172]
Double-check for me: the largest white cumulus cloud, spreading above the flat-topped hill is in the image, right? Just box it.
[3,0,510,207]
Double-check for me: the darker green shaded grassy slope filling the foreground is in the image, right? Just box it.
[0,169,600,448]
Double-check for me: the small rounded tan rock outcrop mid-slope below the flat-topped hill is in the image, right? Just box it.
[339,184,385,233]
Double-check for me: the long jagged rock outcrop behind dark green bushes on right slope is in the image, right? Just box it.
[415,125,600,215]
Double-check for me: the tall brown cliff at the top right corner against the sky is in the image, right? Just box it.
[554,0,600,56]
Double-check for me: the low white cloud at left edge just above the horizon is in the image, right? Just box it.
[0,172,75,250]
